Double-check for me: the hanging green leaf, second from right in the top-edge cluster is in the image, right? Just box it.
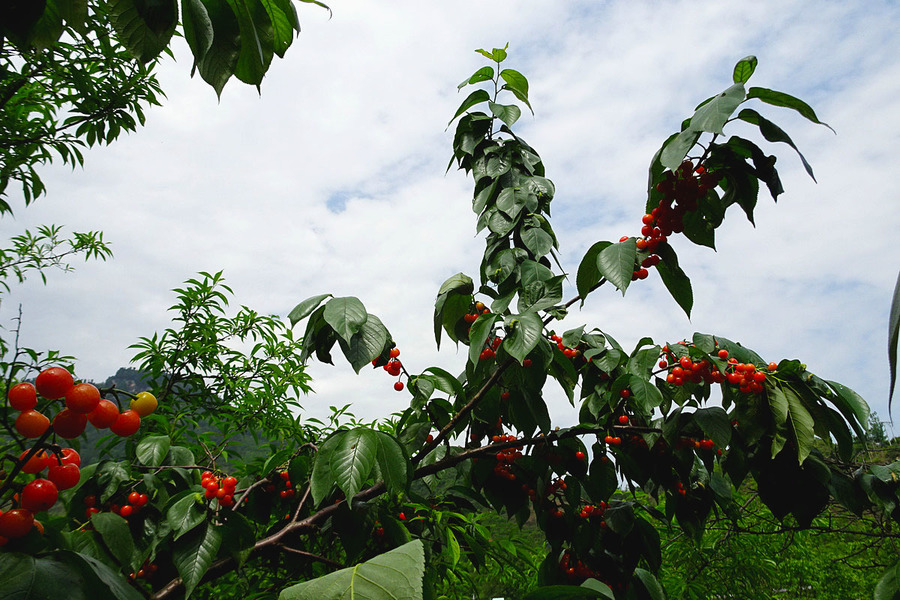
[228,0,275,86]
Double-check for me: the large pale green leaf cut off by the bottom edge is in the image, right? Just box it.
[278,540,425,600]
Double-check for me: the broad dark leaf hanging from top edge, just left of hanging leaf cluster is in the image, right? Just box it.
[108,0,178,63]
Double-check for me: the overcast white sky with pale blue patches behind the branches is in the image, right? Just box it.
[0,0,900,432]
